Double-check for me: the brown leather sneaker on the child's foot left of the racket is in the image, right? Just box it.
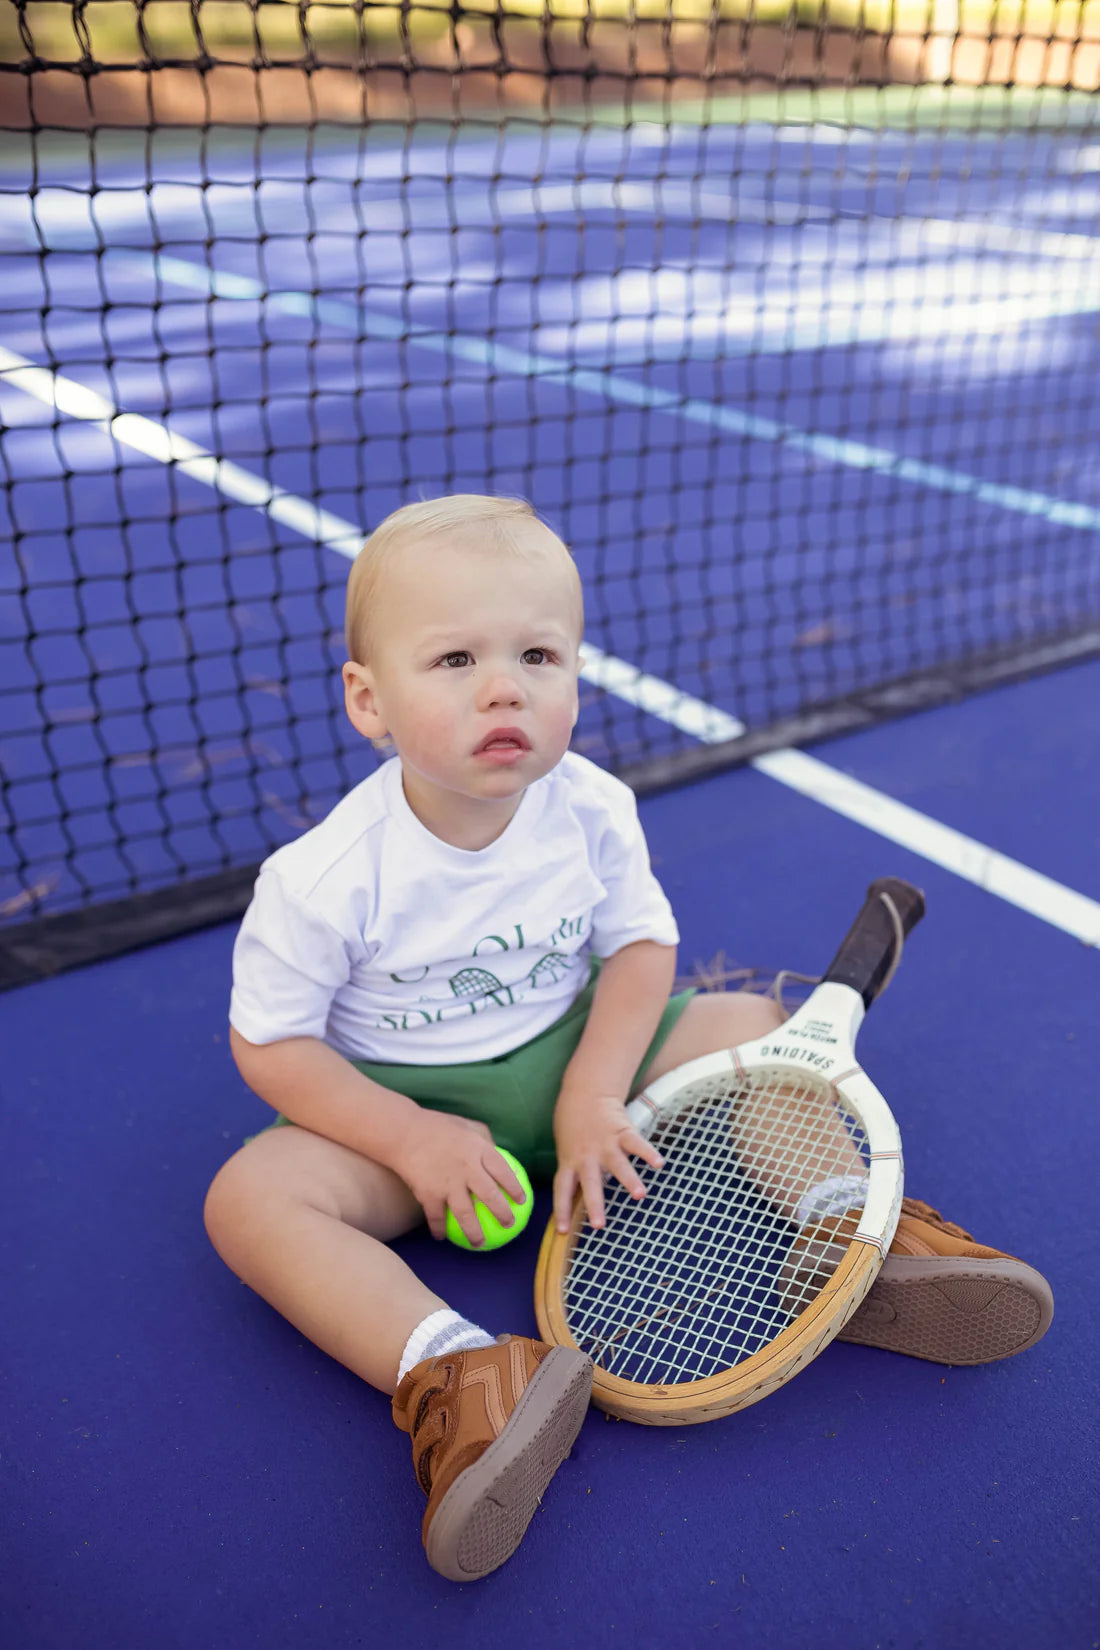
[393,1335,592,1581]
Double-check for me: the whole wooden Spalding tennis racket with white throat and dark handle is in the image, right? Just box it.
[534,878,924,1426]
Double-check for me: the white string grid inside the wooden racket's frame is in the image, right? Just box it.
[564,1073,869,1384]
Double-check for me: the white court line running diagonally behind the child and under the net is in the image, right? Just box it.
[0,347,1100,947]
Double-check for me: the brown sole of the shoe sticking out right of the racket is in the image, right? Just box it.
[838,1256,1054,1365]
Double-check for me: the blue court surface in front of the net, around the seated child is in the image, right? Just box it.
[0,667,1100,1650]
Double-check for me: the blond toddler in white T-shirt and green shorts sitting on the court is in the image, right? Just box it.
[206,495,1049,1579]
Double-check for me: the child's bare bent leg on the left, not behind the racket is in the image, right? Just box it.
[204,1127,447,1393]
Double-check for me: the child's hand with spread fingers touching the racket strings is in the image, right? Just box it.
[554,1089,665,1233]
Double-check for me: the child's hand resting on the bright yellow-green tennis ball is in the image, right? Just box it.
[391,1107,524,1247]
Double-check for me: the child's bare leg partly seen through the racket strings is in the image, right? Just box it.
[642,992,866,1219]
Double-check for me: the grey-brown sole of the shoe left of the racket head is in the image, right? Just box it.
[424,1346,592,1581]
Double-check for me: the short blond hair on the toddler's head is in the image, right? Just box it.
[345,493,584,665]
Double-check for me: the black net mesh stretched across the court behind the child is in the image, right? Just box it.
[0,0,1100,983]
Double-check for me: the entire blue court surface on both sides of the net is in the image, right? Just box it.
[0,106,1100,1650]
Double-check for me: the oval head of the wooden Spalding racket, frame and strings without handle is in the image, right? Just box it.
[534,1016,902,1426]
